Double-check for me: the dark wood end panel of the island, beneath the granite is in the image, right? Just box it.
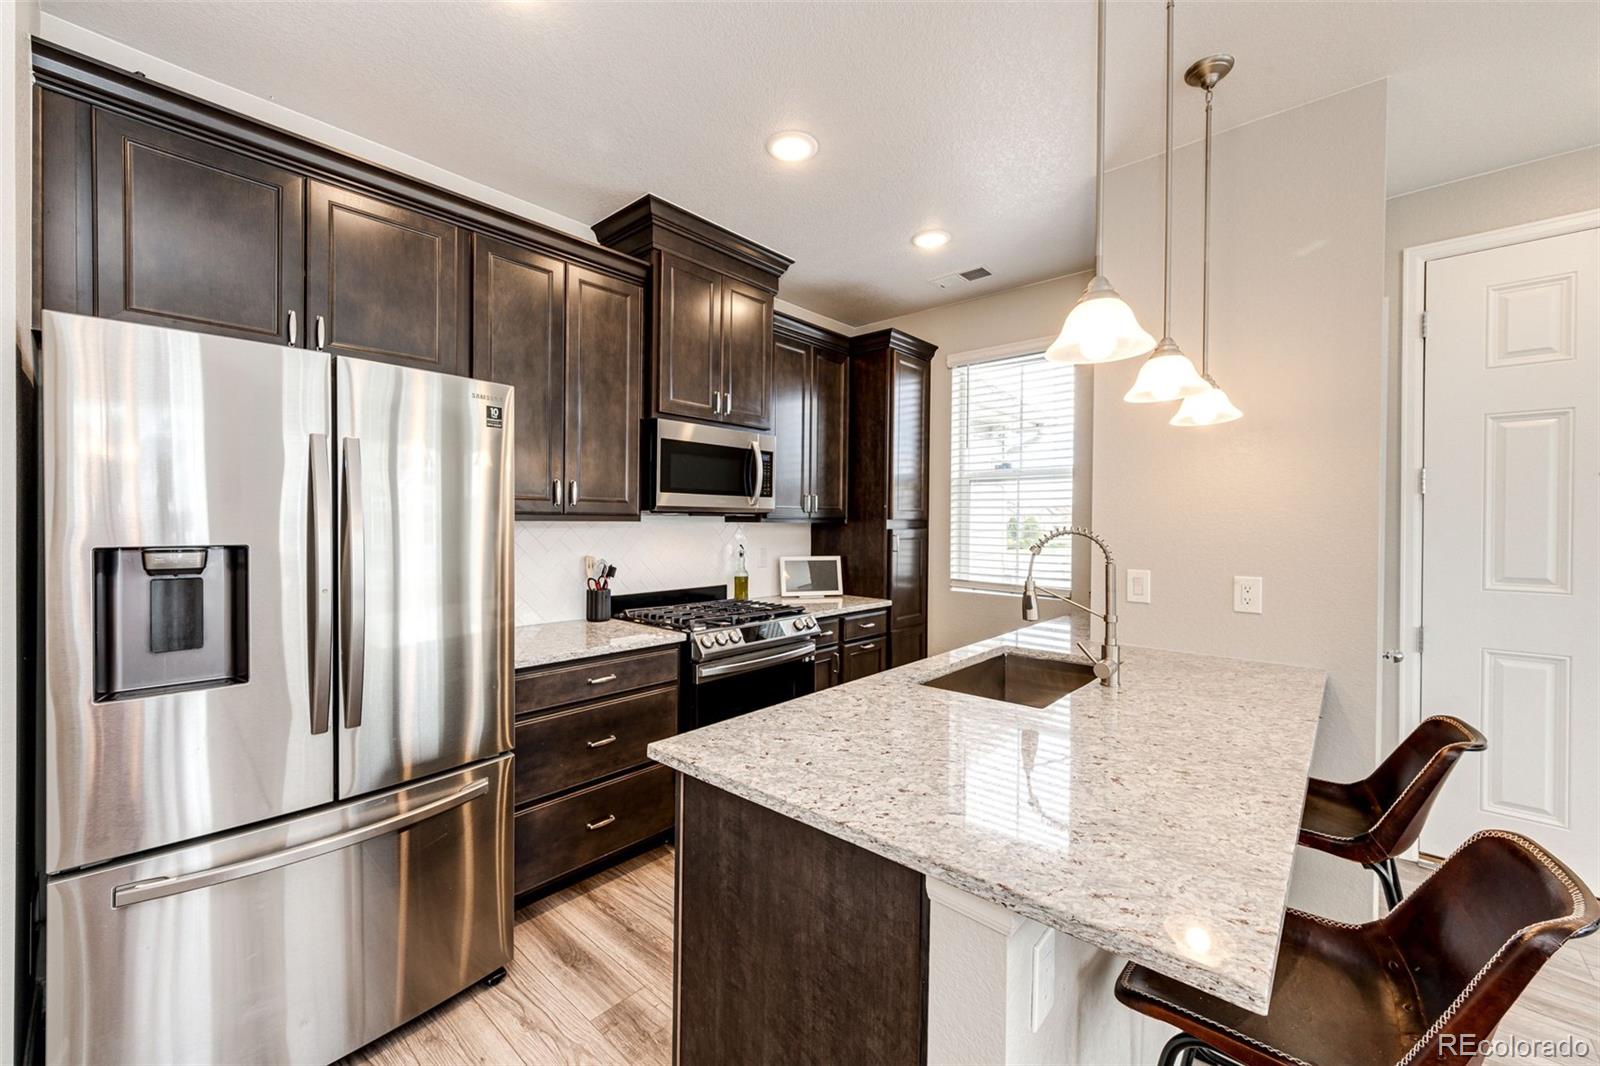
[672,778,928,1066]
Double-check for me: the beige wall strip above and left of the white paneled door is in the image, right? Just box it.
[1381,146,1600,749]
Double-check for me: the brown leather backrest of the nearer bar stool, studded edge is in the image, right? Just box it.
[1378,829,1600,1066]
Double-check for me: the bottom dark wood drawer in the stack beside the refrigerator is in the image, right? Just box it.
[515,767,672,892]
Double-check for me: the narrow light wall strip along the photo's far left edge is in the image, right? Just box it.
[0,0,38,1056]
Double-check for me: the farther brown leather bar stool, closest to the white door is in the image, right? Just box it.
[1299,715,1488,908]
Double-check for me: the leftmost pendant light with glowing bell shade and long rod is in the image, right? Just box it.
[1045,0,1155,365]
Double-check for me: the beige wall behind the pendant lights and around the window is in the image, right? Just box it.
[874,83,1386,917]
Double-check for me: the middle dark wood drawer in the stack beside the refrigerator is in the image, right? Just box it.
[517,683,678,804]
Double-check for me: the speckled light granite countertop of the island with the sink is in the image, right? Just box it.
[650,615,1325,1012]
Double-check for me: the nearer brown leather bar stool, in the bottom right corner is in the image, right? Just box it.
[1117,829,1600,1066]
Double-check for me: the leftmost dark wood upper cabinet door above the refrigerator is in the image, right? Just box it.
[94,110,306,344]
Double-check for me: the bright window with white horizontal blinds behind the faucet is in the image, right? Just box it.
[950,354,1077,591]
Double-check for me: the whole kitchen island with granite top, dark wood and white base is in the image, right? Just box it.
[650,615,1325,1063]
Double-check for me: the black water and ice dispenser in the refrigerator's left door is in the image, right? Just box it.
[94,544,250,701]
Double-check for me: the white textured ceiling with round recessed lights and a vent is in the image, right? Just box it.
[43,0,1600,323]
